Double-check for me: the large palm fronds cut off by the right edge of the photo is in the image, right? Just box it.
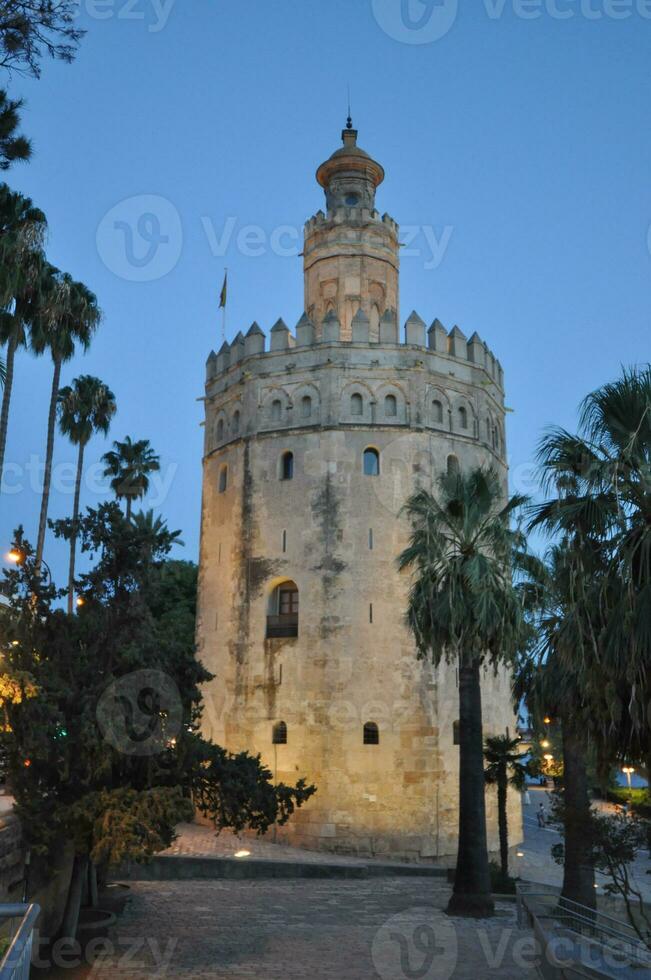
[532,365,651,796]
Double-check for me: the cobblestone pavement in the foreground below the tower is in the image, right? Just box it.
[85,878,537,980]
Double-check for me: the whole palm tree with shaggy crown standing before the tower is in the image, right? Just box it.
[399,469,526,916]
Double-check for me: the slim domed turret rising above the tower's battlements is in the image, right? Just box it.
[304,117,399,342]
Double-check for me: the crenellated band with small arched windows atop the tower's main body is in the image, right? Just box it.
[205,309,506,462]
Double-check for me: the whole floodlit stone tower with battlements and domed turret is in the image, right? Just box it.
[197,120,521,859]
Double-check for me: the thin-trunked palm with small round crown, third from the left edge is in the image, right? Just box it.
[58,374,116,614]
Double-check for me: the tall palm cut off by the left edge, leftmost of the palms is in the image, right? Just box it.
[0,184,47,488]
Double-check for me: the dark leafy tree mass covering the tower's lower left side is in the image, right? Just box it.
[0,503,314,888]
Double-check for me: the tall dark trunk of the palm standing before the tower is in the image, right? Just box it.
[447,659,494,918]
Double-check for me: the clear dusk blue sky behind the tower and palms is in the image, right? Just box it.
[0,0,651,578]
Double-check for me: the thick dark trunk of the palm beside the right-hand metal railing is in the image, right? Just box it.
[561,721,596,908]
